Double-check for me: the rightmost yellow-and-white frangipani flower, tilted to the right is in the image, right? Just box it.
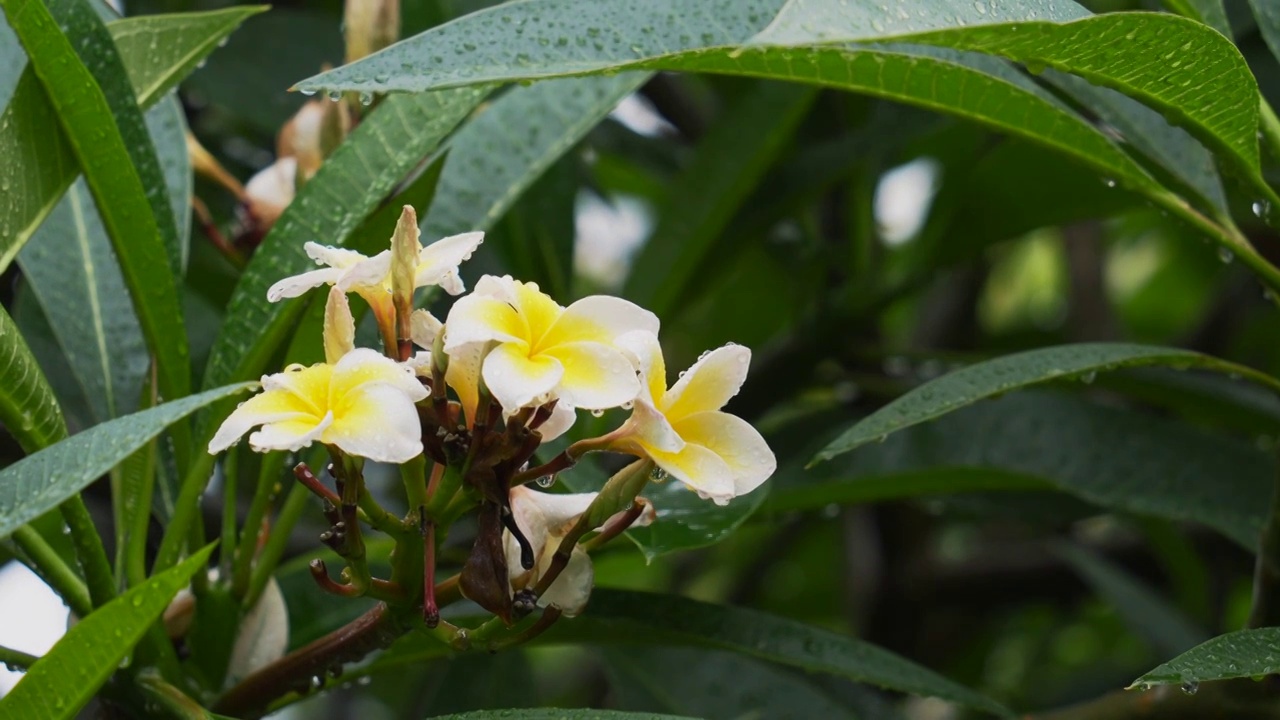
[608,333,778,505]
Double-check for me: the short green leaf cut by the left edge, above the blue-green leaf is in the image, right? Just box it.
[0,301,67,450]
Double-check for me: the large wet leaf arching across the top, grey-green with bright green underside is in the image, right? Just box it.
[298,0,1260,174]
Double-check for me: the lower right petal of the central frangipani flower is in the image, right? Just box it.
[538,342,640,410]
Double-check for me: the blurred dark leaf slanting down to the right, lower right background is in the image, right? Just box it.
[1053,543,1207,657]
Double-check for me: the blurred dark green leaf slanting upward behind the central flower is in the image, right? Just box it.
[623,82,818,318]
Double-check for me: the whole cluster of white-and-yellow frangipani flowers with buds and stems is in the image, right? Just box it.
[209,206,776,624]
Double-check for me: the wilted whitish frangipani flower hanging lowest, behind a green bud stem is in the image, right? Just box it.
[503,486,655,618]
